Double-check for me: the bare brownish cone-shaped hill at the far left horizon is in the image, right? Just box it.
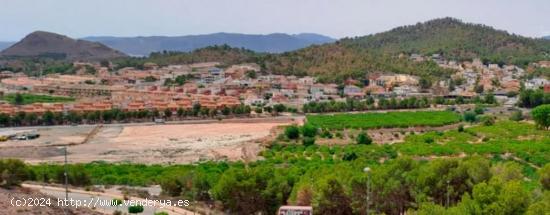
[0,31,126,60]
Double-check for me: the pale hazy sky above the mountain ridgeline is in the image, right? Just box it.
[0,0,550,41]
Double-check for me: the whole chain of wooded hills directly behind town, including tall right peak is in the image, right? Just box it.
[119,18,550,83]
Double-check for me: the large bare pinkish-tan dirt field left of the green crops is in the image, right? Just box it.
[0,118,298,164]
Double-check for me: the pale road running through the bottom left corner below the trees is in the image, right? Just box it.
[22,184,196,215]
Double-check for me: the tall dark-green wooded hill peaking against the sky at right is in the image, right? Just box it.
[341,18,550,64]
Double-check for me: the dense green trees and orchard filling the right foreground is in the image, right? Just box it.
[16,122,550,214]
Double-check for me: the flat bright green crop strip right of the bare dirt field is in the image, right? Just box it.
[307,111,461,129]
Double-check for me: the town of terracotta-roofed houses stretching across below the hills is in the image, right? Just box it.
[0,54,550,121]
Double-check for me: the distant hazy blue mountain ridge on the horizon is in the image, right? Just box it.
[83,33,335,56]
